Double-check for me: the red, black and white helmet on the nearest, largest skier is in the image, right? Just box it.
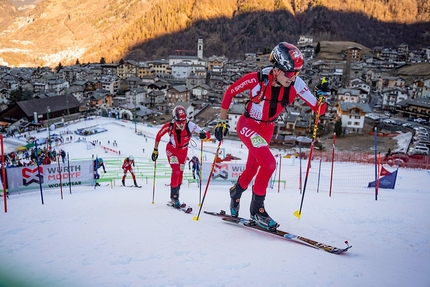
[269,42,304,72]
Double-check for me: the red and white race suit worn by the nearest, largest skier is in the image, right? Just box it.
[221,69,326,196]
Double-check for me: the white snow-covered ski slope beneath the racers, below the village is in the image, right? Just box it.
[0,118,430,287]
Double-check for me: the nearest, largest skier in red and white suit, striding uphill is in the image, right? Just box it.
[215,42,326,230]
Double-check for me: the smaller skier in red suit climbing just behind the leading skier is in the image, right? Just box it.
[151,106,210,208]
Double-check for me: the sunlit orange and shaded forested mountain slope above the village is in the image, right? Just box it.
[0,0,430,66]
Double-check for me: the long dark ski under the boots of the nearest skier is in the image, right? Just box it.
[204,210,352,254]
